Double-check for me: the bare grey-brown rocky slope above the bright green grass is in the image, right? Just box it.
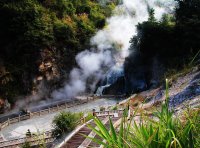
[140,65,200,108]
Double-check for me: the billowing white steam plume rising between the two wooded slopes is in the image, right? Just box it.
[52,0,175,99]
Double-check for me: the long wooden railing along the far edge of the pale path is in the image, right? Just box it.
[0,97,96,130]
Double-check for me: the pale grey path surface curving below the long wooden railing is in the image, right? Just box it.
[0,99,117,140]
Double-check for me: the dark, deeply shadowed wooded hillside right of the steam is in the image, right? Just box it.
[125,0,200,93]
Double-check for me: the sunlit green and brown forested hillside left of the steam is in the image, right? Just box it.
[0,0,117,103]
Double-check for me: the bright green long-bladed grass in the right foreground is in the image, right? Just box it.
[88,80,200,148]
